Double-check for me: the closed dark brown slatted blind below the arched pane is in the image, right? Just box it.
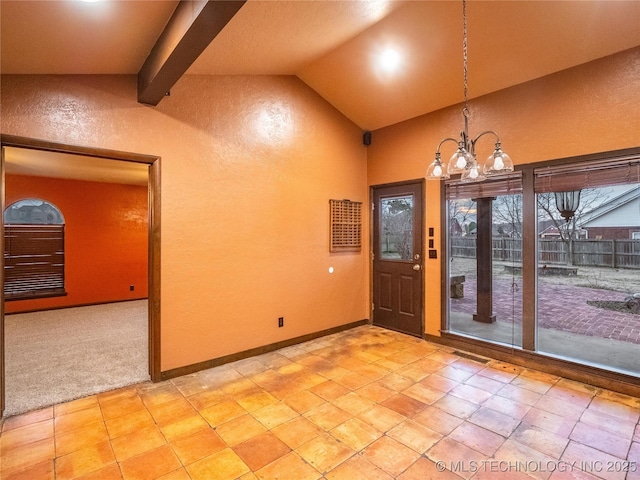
[4,225,65,300]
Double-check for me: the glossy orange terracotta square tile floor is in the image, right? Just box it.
[0,326,640,480]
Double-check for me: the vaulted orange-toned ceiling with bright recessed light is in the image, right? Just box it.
[0,0,640,183]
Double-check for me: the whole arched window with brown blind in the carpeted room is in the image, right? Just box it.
[4,198,66,300]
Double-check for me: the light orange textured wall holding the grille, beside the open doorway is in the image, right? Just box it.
[0,75,369,370]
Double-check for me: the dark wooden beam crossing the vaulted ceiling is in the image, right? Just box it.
[138,0,246,105]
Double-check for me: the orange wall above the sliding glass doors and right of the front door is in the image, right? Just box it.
[368,48,640,335]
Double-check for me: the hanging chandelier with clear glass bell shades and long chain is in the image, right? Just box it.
[426,0,513,182]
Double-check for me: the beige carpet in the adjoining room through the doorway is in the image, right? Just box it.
[4,300,149,416]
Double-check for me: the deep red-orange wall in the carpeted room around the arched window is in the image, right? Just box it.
[5,174,149,313]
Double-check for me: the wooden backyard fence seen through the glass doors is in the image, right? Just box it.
[451,237,640,269]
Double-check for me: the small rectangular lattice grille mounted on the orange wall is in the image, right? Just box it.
[329,200,362,252]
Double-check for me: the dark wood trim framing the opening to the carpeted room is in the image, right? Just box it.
[0,134,162,418]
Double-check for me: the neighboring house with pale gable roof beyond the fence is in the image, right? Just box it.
[580,186,640,240]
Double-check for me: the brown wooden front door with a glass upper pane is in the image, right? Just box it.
[373,181,424,337]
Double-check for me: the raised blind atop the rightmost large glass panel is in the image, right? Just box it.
[534,154,640,193]
